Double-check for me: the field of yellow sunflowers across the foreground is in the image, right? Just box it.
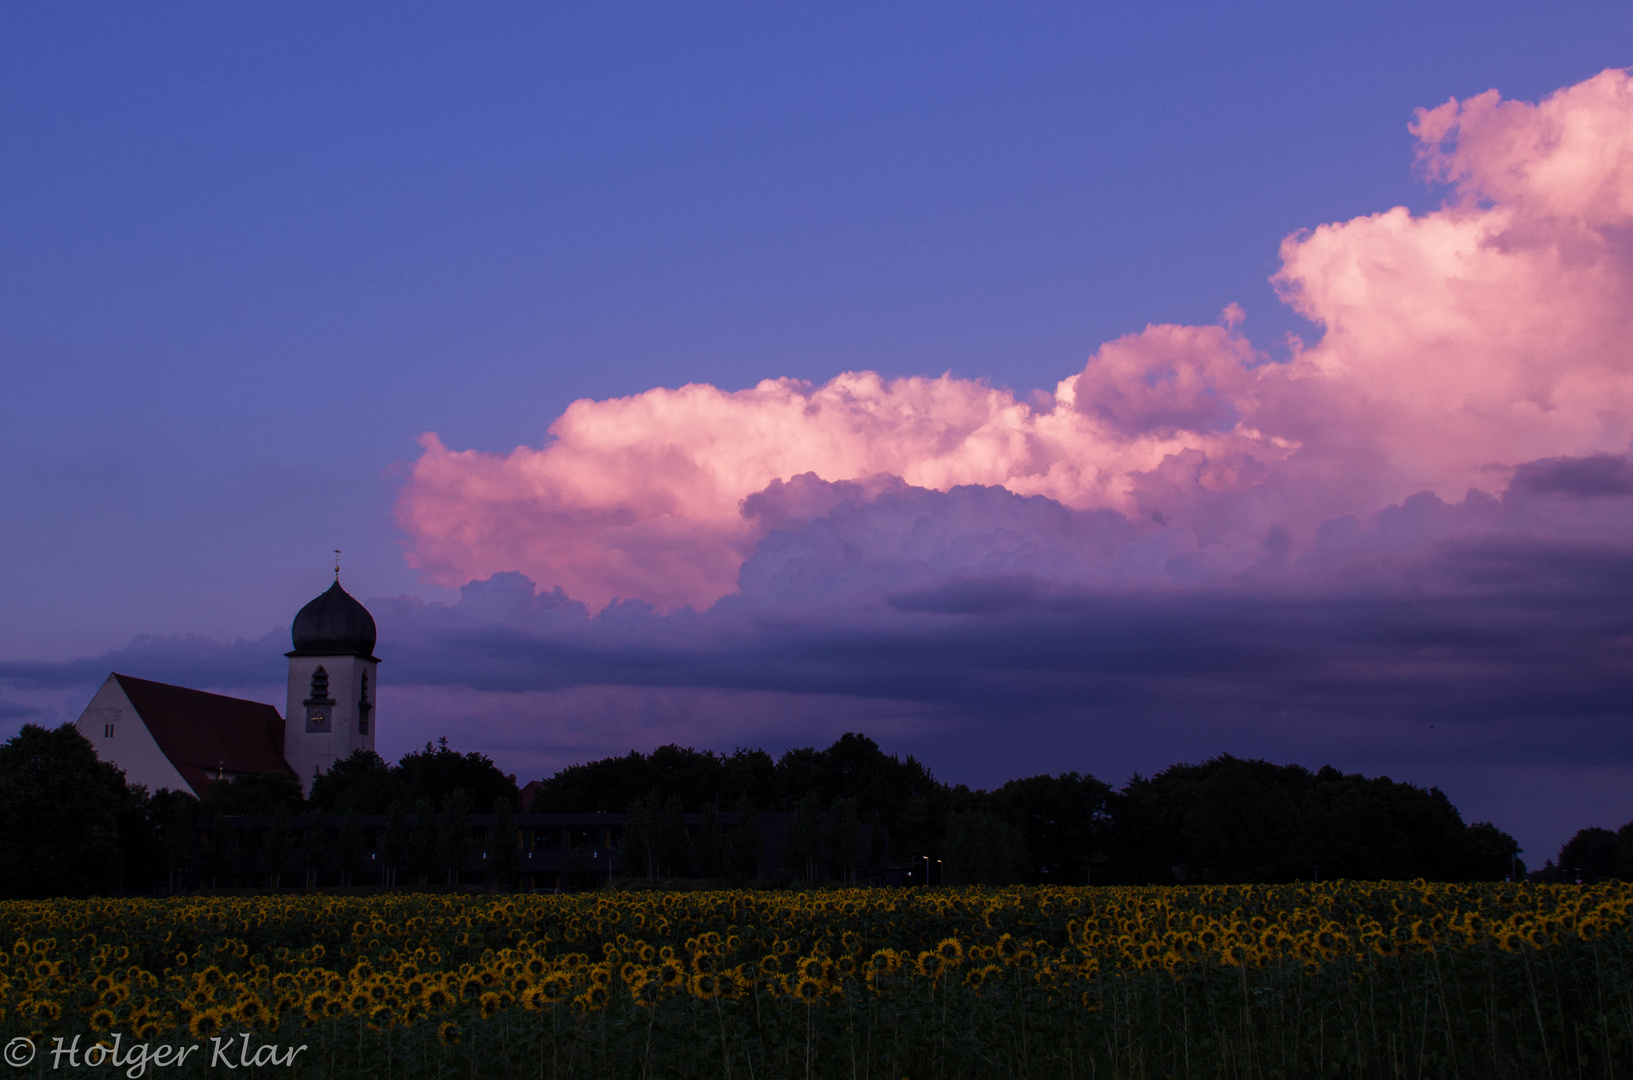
[0,882,1633,1080]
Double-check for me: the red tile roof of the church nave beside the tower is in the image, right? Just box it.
[114,672,299,796]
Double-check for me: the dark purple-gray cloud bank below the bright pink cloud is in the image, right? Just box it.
[9,459,1633,843]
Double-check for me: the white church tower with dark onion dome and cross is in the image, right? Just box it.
[284,564,380,792]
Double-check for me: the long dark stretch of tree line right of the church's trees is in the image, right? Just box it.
[532,734,1525,884]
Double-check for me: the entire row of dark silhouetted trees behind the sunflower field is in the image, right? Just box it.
[0,725,1554,895]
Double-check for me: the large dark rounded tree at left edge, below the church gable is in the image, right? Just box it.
[0,724,129,897]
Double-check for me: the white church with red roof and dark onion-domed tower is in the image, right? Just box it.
[75,578,380,797]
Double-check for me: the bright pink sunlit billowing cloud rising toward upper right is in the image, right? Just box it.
[397,70,1633,609]
